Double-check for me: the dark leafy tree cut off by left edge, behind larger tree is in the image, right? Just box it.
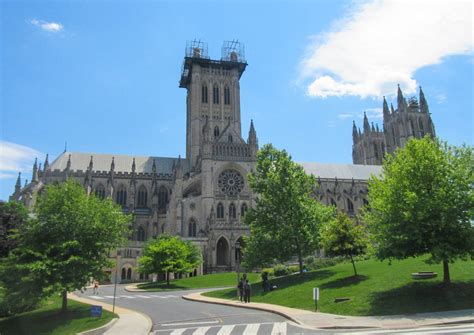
[0,201,28,258]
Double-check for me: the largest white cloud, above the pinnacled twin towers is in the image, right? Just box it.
[300,0,474,98]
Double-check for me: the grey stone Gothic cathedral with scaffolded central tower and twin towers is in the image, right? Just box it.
[10,41,434,282]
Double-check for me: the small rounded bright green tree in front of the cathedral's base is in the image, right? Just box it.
[138,234,202,285]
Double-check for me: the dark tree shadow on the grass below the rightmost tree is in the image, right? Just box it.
[369,280,474,315]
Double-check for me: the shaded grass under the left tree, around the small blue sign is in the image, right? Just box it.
[0,296,117,335]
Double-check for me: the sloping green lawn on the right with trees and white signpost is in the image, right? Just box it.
[205,258,474,315]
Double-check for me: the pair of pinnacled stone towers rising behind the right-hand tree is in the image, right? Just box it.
[352,86,436,165]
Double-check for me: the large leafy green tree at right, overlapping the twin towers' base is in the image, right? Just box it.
[364,137,474,285]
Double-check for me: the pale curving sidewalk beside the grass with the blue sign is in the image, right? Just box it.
[68,293,153,335]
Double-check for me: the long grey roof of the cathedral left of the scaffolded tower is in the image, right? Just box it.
[50,152,187,173]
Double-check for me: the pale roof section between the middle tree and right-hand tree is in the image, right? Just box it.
[298,163,382,180]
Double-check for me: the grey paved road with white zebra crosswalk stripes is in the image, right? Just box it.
[76,285,474,335]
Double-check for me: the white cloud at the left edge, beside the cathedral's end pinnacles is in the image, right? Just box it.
[0,141,44,179]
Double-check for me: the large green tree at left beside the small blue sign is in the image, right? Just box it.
[2,180,131,312]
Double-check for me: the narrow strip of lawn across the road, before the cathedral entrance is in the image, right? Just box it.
[138,272,260,291]
